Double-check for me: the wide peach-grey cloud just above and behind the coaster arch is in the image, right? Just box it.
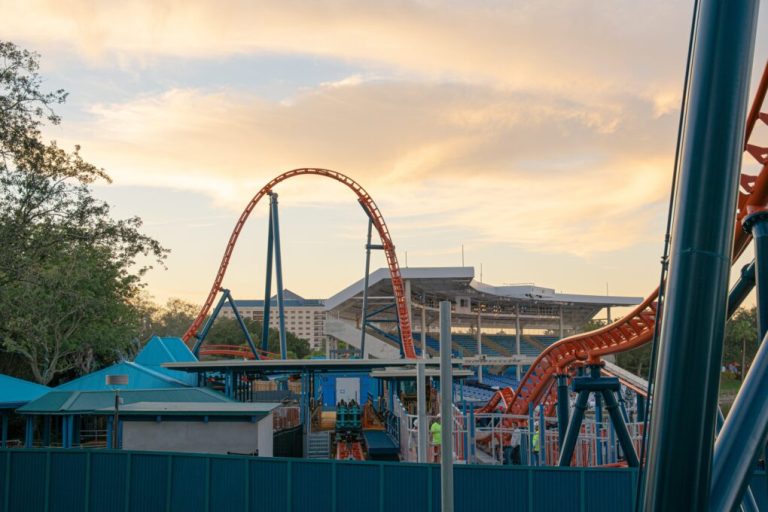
[54,79,675,255]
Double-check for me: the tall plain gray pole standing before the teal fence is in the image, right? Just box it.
[440,300,453,512]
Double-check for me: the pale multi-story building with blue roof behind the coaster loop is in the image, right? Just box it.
[221,289,325,349]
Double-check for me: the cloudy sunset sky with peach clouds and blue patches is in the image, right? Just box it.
[0,0,768,310]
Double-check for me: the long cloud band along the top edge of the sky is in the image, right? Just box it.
[0,0,692,97]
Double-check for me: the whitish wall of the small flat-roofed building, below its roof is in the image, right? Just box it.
[123,413,273,457]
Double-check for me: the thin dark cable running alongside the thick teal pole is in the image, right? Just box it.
[635,0,699,511]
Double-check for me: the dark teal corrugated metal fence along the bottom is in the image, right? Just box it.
[0,449,636,512]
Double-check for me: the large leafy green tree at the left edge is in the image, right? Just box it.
[0,42,167,384]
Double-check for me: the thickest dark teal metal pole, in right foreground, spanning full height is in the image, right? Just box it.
[643,0,762,511]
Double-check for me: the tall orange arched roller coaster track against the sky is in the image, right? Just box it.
[183,168,416,359]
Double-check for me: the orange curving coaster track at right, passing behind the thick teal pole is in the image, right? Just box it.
[479,62,768,415]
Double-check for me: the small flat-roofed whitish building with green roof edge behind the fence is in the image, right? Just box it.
[120,402,280,457]
